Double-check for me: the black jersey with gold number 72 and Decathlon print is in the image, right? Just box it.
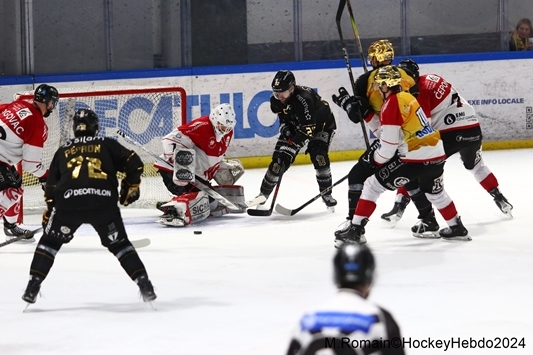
[45,137,143,211]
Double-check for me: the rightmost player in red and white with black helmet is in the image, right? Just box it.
[382,59,513,234]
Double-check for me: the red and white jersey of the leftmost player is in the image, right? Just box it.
[0,100,48,178]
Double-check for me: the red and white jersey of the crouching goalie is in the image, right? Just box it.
[154,116,233,180]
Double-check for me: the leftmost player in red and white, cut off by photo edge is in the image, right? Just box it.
[0,84,59,242]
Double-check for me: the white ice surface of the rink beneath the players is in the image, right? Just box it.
[0,149,533,355]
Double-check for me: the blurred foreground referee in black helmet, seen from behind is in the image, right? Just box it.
[287,244,405,355]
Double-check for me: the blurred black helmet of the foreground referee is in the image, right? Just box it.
[333,243,376,288]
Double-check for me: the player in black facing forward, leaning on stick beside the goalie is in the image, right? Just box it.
[255,70,337,209]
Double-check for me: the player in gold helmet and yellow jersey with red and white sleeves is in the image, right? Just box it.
[335,65,471,246]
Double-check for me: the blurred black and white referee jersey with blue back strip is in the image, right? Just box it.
[287,289,404,355]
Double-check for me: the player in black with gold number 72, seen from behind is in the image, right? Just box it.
[22,109,156,304]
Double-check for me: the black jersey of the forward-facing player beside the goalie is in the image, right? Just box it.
[270,85,337,138]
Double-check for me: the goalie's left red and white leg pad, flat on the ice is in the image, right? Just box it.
[162,191,211,226]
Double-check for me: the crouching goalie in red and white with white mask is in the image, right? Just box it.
[154,104,244,227]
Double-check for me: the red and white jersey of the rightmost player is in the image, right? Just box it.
[416,74,479,132]
